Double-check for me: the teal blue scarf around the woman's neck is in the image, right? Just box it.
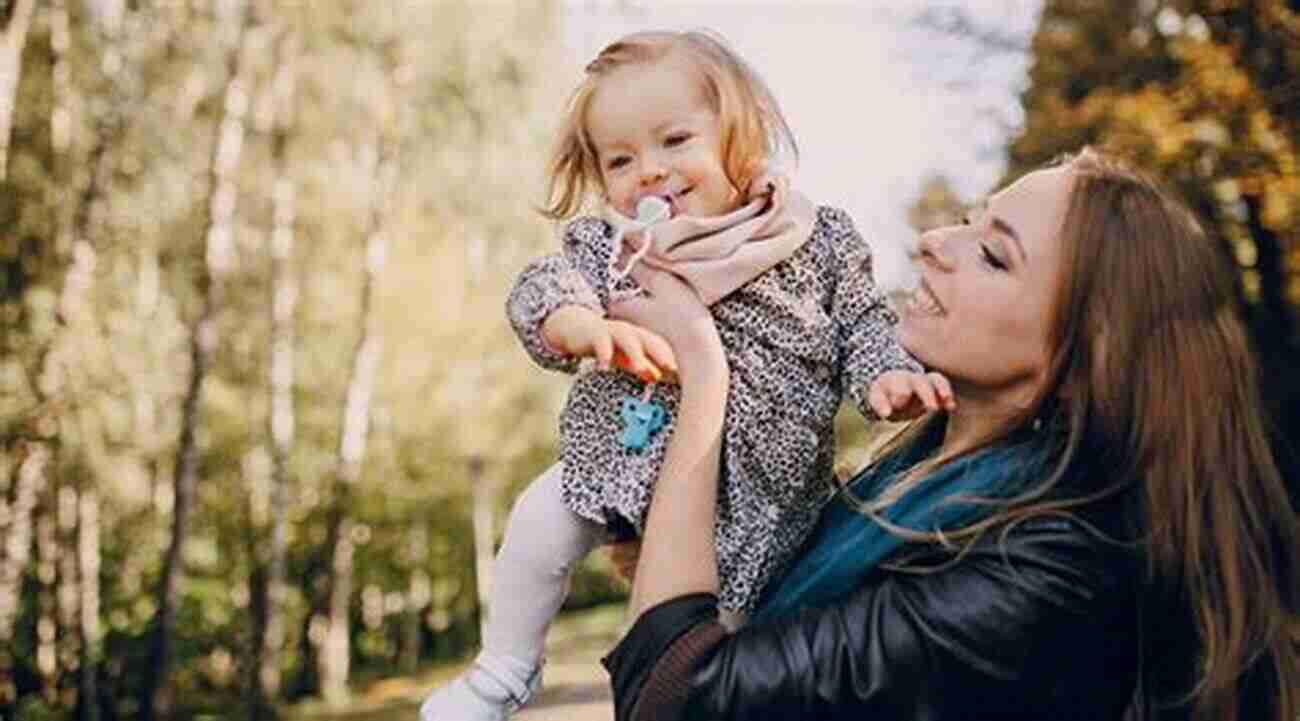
[750,427,1054,622]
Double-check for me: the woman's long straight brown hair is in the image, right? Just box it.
[873,148,1300,721]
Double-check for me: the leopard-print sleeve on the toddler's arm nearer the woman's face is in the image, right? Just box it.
[827,210,924,421]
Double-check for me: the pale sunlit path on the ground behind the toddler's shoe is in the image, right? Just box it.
[287,605,623,721]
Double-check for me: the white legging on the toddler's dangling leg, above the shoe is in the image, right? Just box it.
[484,464,607,668]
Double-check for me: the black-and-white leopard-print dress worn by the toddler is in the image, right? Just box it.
[506,207,920,612]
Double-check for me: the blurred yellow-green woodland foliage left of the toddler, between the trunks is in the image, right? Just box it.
[0,1,569,718]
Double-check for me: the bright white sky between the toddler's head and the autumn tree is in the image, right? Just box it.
[562,0,1039,288]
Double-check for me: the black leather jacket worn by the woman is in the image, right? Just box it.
[605,517,1143,721]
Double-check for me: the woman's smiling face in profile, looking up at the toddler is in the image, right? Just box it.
[898,168,1071,407]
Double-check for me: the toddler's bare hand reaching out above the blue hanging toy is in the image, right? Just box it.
[542,305,677,383]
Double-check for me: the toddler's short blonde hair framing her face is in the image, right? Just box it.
[542,31,798,220]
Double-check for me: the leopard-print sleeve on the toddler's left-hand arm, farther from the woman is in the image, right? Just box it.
[506,218,612,373]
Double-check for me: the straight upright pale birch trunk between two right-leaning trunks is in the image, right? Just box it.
[248,28,298,720]
